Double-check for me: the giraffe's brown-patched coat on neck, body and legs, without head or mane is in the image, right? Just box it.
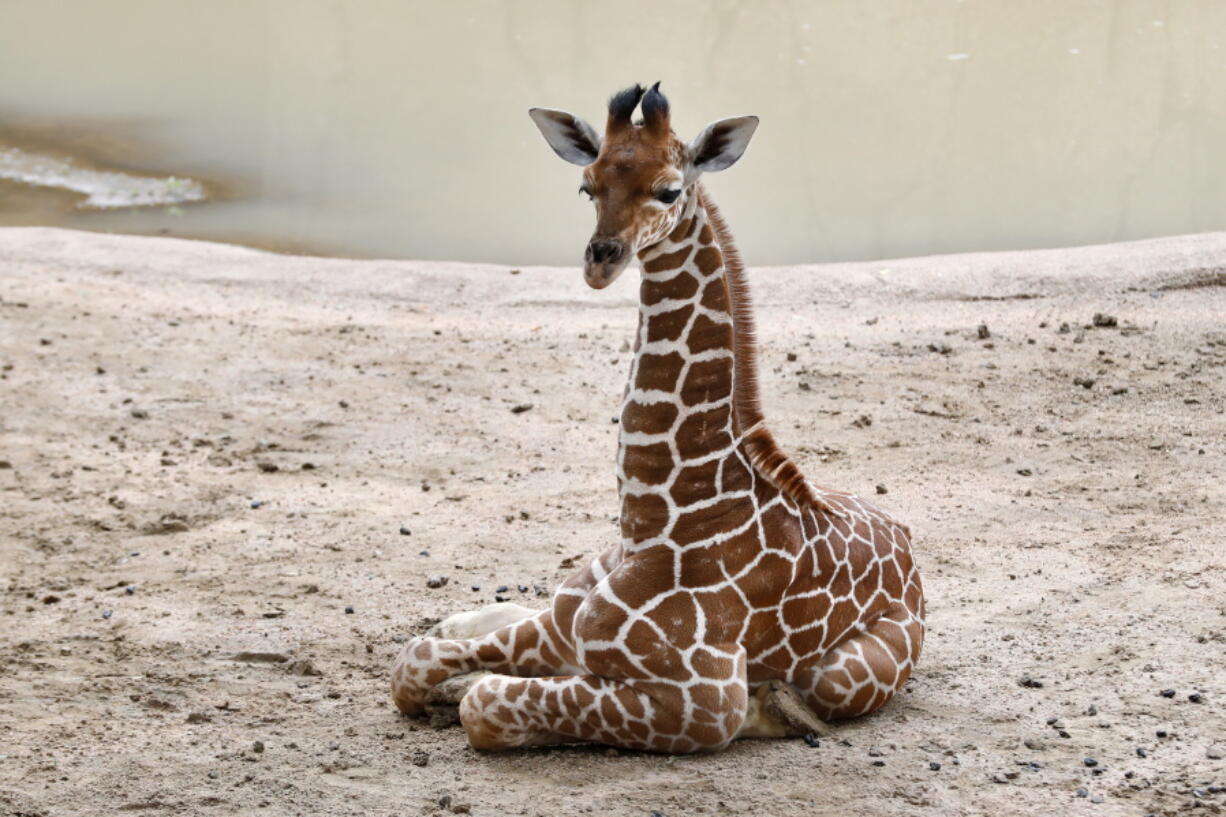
[392,180,924,752]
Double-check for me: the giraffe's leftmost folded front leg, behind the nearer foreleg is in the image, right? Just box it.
[391,610,577,715]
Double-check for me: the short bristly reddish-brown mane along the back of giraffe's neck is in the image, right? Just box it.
[696,183,841,515]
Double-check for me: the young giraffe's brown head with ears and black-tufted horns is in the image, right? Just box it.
[528,82,758,290]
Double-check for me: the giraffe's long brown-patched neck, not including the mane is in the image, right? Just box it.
[618,189,741,548]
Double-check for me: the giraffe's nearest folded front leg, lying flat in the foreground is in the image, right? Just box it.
[460,658,748,753]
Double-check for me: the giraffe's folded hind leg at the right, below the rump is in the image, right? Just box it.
[793,604,923,720]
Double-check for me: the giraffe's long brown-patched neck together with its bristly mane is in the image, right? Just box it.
[618,184,839,548]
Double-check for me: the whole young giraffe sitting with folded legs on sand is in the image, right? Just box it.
[391,83,924,753]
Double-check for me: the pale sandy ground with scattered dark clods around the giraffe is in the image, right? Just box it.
[0,228,1226,817]
